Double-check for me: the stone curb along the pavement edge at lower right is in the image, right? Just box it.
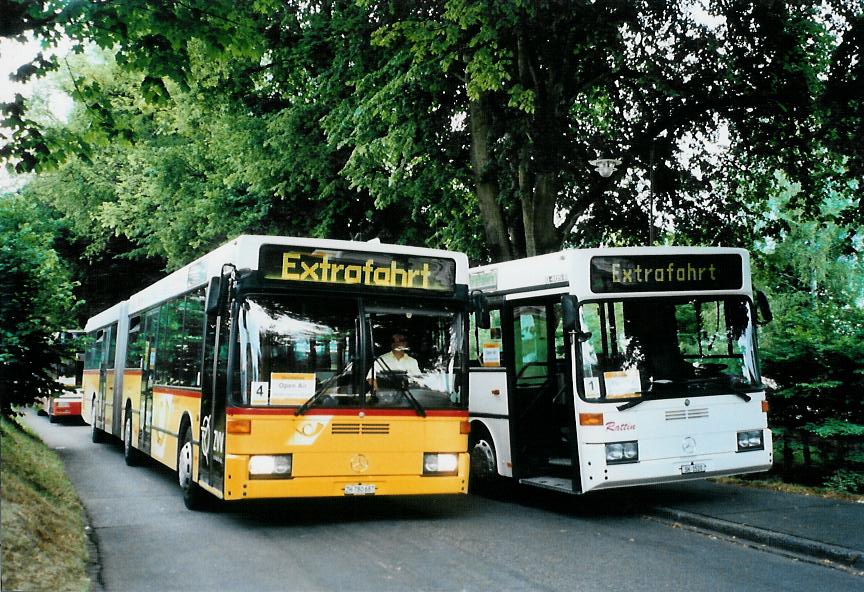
[651,507,864,569]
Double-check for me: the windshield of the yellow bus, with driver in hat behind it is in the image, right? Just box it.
[236,295,463,414]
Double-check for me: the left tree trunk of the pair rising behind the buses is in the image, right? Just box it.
[469,99,513,261]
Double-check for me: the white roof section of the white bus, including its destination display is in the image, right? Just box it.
[469,247,752,300]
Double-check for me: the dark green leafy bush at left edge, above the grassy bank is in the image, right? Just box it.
[0,195,74,416]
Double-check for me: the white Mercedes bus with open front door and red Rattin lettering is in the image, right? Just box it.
[469,247,773,494]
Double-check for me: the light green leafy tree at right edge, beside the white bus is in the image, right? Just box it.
[755,175,864,490]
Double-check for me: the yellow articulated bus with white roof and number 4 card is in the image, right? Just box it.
[82,236,469,509]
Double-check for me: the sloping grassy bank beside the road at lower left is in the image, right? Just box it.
[0,418,90,591]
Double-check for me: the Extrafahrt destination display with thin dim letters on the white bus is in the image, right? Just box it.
[591,253,743,294]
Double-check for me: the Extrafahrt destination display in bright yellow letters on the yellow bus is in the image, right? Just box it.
[259,245,456,293]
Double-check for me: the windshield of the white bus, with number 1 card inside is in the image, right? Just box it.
[580,296,762,401]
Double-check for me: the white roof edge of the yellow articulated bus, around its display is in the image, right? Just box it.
[85,234,468,331]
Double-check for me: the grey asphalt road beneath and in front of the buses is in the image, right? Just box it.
[26,415,862,592]
